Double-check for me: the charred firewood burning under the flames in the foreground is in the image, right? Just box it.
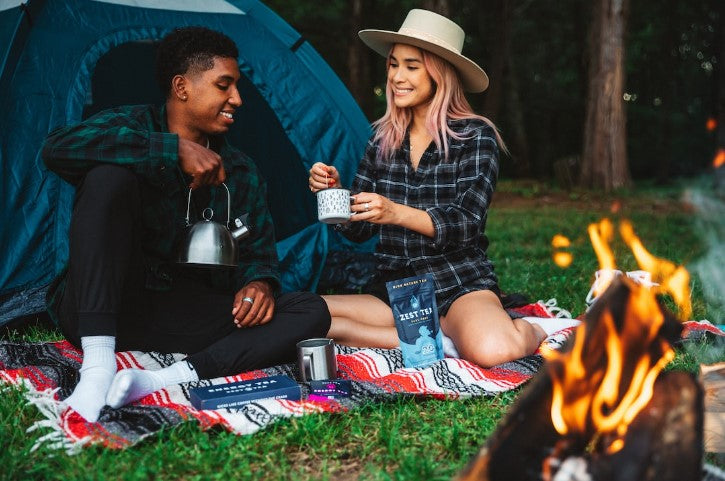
[456,280,700,481]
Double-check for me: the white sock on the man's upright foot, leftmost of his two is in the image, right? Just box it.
[63,336,116,423]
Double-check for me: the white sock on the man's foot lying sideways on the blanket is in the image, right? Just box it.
[106,361,199,408]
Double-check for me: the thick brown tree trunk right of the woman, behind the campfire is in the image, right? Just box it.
[580,0,631,192]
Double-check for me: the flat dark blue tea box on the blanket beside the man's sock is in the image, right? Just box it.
[190,375,302,409]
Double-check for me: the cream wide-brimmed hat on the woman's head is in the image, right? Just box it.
[358,9,488,92]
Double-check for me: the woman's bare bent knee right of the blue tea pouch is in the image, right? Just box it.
[441,291,546,367]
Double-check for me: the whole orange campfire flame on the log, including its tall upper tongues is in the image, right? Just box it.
[542,219,691,453]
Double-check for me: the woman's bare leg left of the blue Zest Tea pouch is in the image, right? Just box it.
[322,294,399,349]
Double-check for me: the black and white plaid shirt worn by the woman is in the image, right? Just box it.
[339,119,498,305]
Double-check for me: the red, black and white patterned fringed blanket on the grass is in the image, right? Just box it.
[0,301,722,454]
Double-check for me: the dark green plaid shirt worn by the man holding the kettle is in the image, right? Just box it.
[42,105,280,306]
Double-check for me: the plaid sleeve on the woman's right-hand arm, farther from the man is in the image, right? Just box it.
[426,127,498,248]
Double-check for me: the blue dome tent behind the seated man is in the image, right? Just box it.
[0,0,369,325]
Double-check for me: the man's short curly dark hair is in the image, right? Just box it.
[156,27,239,96]
